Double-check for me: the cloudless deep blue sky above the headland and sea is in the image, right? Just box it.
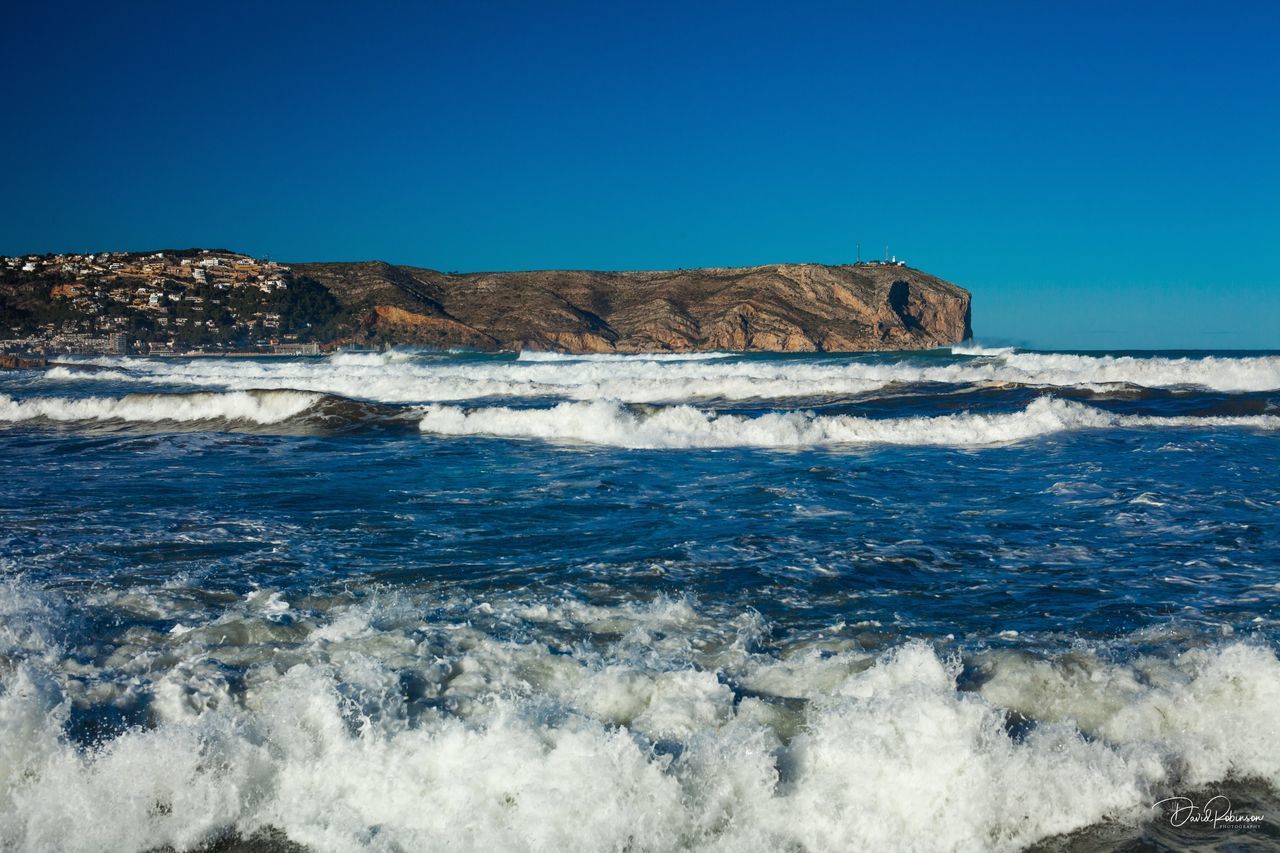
[0,0,1280,348]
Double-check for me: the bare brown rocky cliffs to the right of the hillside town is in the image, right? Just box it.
[294,263,972,352]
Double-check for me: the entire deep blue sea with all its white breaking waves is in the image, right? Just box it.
[0,346,1280,853]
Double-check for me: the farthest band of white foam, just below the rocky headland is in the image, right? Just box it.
[37,350,1280,402]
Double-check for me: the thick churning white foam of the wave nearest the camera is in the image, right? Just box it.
[0,578,1280,852]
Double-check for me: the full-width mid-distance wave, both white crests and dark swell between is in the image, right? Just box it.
[0,389,1280,448]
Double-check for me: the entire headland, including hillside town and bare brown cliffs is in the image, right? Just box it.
[0,248,972,356]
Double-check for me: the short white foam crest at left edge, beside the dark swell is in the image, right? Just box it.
[0,391,320,424]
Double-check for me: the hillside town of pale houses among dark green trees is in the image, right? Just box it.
[0,250,339,356]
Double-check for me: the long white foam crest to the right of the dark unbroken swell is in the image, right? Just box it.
[420,397,1280,448]
